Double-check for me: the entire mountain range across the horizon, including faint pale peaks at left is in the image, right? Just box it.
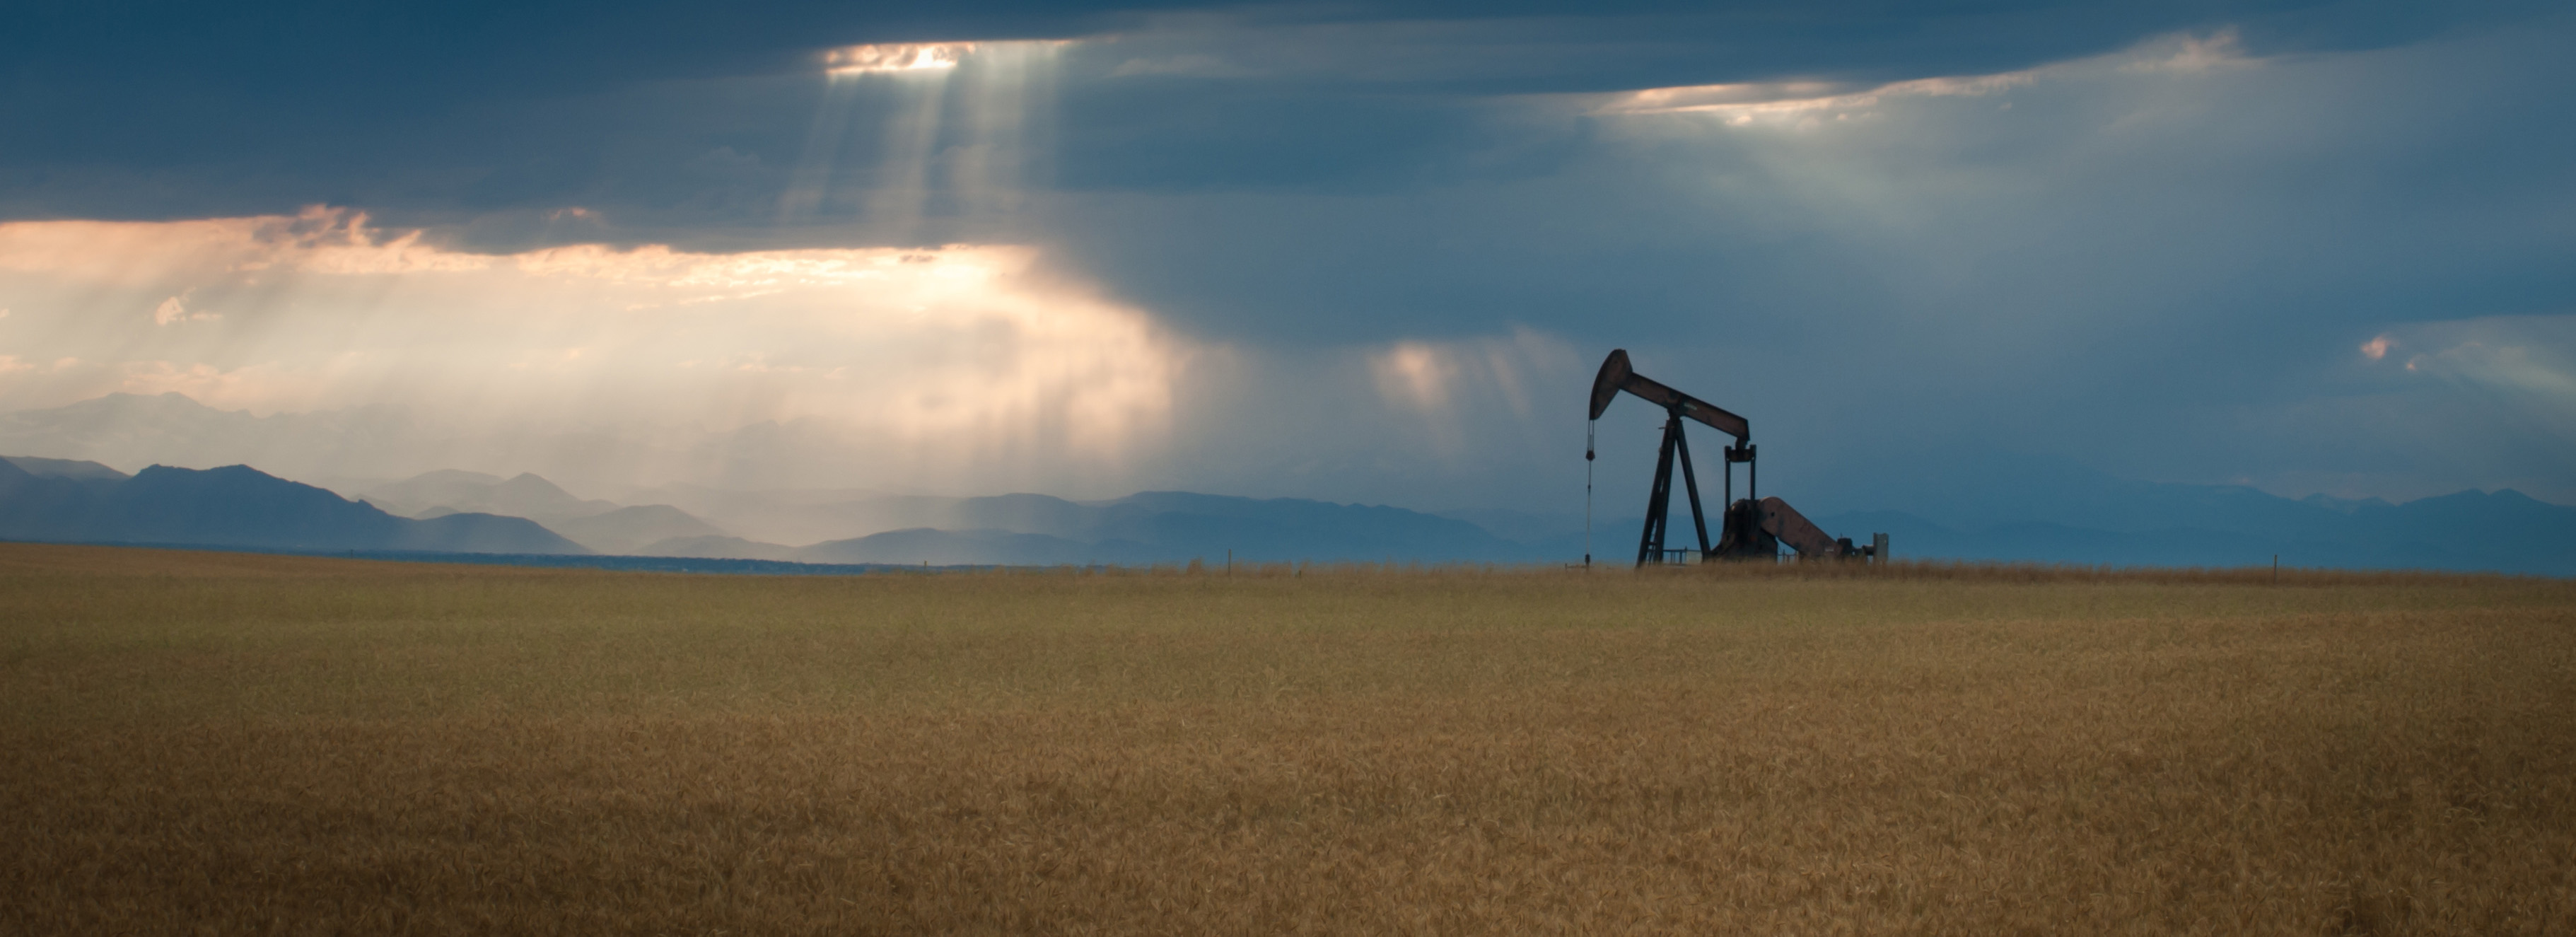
[0,394,2576,576]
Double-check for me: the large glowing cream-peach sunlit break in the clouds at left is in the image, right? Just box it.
[0,209,1187,482]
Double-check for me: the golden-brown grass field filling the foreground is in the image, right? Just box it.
[0,543,2576,934]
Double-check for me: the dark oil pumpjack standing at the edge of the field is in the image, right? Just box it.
[1584,347,1888,566]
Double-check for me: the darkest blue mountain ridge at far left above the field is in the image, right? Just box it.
[0,458,588,554]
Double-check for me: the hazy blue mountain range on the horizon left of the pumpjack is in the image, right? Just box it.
[0,455,1535,566]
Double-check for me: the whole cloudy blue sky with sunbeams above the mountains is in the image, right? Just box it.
[0,3,2576,515]
